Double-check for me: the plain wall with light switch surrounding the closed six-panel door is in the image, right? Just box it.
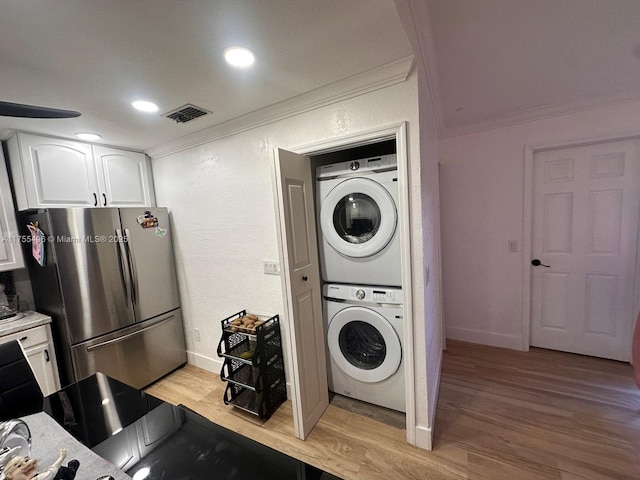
[440,102,640,349]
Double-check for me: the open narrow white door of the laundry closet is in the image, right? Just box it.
[274,149,329,439]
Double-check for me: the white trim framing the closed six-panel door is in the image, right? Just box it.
[521,132,640,351]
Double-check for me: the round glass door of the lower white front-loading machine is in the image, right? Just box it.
[327,307,402,383]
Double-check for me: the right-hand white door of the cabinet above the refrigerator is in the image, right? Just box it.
[93,146,155,207]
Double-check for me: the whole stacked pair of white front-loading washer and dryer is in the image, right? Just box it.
[316,154,405,412]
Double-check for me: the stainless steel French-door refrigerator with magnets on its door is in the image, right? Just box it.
[22,207,187,388]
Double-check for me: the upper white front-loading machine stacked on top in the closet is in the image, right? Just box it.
[316,154,402,287]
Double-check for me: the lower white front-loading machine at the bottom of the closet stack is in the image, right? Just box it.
[323,284,406,412]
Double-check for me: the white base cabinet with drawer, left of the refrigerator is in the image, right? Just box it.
[0,324,60,396]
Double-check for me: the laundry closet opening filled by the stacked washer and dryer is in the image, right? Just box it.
[310,138,406,428]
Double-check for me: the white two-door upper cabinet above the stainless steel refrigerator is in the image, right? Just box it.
[7,133,155,210]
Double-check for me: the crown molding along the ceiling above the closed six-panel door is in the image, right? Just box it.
[440,92,640,139]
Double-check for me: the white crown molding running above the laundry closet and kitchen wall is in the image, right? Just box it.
[146,55,414,158]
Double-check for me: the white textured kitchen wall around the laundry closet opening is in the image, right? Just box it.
[153,74,439,446]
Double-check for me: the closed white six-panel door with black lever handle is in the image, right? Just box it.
[531,140,640,361]
